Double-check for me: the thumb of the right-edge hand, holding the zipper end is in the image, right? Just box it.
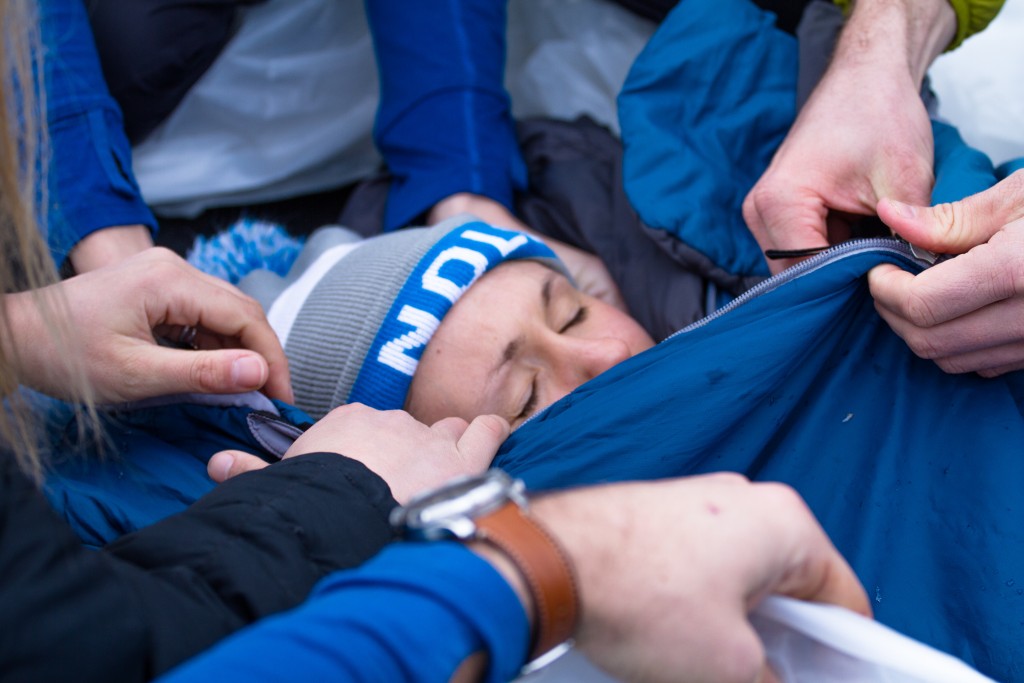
[878,171,1024,254]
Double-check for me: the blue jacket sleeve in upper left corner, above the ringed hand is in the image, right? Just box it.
[40,0,157,266]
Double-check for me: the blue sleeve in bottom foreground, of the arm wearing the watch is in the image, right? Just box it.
[161,543,529,683]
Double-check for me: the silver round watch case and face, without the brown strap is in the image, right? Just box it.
[391,470,525,540]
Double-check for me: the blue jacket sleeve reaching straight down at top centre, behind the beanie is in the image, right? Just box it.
[367,0,526,229]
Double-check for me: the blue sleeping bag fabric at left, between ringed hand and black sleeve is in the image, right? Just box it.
[43,401,312,547]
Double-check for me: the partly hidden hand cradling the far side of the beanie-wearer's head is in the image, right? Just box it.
[427,193,629,312]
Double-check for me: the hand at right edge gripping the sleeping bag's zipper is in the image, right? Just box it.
[867,171,1024,377]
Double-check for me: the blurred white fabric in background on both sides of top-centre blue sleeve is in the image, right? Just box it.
[133,0,654,216]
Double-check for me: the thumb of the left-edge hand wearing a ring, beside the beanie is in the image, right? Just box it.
[139,346,270,396]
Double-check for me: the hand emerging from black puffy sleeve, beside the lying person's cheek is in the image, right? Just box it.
[207,403,509,503]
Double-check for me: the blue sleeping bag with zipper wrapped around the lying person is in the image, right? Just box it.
[41,0,1024,680]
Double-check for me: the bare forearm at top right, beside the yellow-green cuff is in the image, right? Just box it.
[829,0,956,87]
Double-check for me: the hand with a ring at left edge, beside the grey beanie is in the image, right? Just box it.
[4,249,293,402]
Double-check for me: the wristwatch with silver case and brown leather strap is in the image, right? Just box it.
[391,469,580,670]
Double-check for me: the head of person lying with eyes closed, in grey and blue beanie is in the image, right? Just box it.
[240,217,653,427]
